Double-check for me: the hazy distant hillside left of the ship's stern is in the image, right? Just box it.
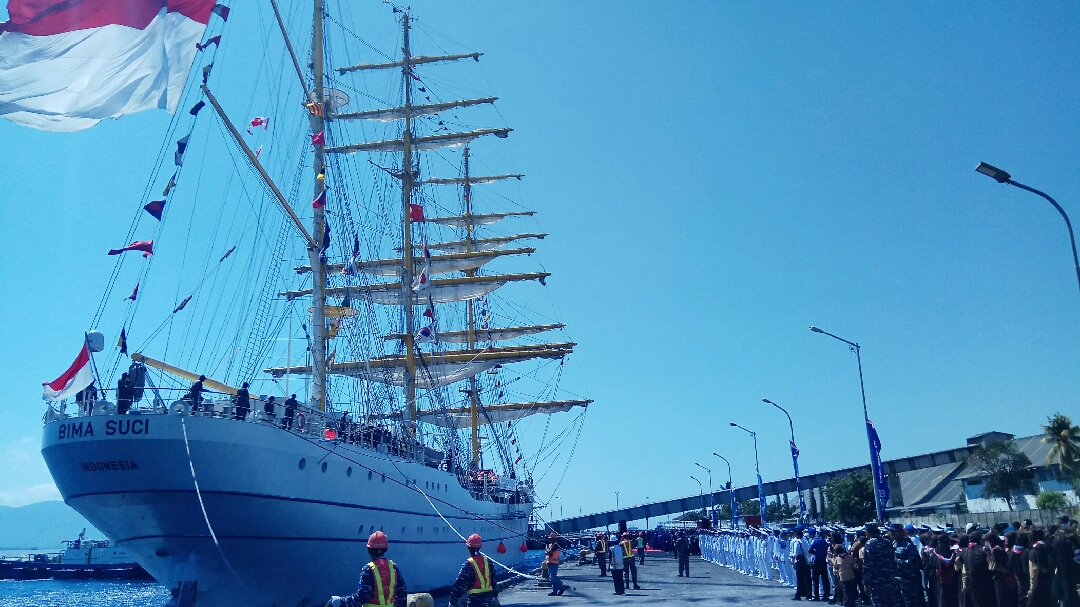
[0,501,105,551]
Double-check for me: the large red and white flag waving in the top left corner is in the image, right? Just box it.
[0,0,214,131]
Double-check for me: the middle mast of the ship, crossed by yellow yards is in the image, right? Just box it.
[401,14,416,435]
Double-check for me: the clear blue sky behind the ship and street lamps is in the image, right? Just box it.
[0,1,1080,514]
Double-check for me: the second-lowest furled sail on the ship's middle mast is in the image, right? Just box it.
[281,272,551,306]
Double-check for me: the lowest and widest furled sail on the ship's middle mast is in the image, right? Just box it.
[265,343,575,389]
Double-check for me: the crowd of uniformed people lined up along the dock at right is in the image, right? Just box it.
[700,516,1080,607]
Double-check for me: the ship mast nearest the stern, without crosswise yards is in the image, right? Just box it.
[308,0,326,410]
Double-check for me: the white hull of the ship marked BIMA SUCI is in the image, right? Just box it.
[42,415,531,607]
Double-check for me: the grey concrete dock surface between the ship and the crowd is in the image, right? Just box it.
[488,553,786,607]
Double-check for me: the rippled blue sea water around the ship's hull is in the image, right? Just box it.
[0,550,543,607]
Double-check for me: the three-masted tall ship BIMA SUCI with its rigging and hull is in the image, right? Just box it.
[8,0,592,607]
